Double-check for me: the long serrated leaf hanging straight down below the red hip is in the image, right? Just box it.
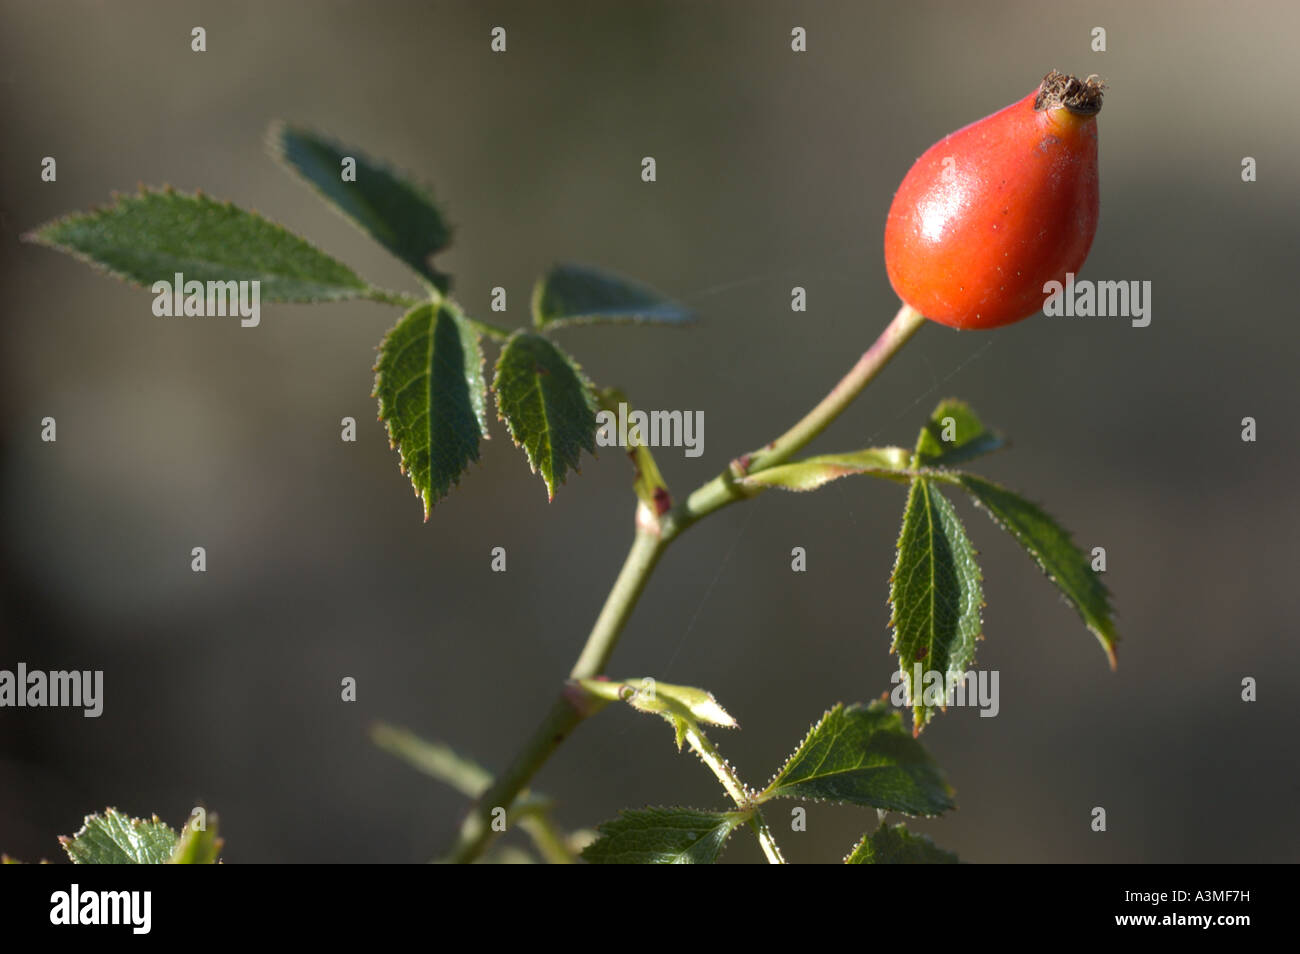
[889,477,984,734]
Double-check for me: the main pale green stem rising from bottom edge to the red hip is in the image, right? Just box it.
[445,304,924,863]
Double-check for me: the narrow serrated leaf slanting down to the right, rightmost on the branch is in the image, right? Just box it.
[945,473,1119,669]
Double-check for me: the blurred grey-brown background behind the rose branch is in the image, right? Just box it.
[0,0,1300,862]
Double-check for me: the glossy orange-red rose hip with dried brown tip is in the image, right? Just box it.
[885,70,1102,329]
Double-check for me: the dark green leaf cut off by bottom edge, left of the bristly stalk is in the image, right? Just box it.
[582,808,750,864]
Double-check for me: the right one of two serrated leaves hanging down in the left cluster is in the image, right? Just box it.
[491,331,595,500]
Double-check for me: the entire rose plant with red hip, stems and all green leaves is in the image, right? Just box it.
[17,71,1118,864]
